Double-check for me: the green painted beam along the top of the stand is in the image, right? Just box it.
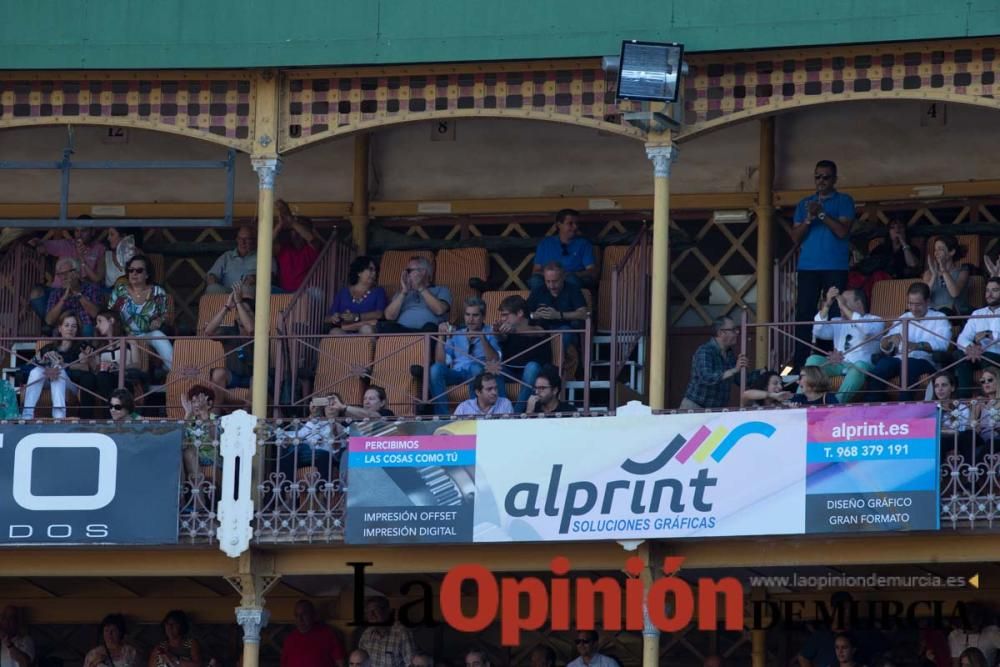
[0,0,1000,70]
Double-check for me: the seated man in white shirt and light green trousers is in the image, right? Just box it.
[805,287,885,404]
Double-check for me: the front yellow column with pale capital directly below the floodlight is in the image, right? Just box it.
[646,144,677,410]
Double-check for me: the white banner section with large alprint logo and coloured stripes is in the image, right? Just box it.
[474,410,806,542]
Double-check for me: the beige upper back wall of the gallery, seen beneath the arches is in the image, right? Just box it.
[0,101,1000,203]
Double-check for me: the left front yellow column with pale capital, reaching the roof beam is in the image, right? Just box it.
[245,71,281,418]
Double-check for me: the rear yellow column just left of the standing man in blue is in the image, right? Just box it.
[754,116,774,368]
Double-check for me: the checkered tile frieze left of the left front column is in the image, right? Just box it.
[0,78,253,148]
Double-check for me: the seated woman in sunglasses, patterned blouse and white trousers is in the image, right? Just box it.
[108,255,174,371]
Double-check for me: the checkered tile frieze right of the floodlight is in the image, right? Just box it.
[683,41,1000,134]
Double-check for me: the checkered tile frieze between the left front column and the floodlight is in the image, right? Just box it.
[282,68,641,148]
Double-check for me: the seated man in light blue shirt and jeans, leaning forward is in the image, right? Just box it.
[430,296,507,415]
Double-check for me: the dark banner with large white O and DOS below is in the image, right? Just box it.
[0,423,183,545]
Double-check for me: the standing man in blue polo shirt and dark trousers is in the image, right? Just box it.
[792,160,854,366]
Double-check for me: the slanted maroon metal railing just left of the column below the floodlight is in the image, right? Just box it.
[604,226,652,410]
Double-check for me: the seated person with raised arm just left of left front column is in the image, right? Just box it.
[205,273,257,396]
